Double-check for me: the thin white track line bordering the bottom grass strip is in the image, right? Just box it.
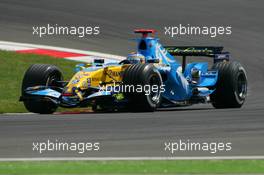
[0,156,264,162]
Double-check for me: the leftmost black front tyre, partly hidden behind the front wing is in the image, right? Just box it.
[21,64,63,114]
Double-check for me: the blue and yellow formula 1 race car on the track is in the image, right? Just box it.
[20,29,247,114]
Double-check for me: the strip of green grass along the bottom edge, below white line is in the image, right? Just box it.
[0,160,264,174]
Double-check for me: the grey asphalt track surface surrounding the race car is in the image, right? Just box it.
[0,0,264,158]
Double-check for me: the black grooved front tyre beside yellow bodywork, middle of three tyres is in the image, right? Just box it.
[123,64,162,112]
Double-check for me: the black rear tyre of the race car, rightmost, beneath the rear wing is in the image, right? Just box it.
[210,62,247,108]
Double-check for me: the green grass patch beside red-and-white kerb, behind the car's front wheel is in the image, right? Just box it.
[0,51,80,113]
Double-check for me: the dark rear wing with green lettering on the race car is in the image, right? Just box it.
[164,46,230,71]
